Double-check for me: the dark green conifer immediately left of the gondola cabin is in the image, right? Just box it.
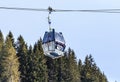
[31,40,48,82]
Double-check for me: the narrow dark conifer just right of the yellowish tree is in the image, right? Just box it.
[16,35,28,82]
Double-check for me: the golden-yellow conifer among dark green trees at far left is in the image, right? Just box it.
[1,36,20,82]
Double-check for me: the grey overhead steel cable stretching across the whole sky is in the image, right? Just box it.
[0,7,120,13]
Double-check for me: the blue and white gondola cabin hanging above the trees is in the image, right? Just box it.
[42,29,66,59]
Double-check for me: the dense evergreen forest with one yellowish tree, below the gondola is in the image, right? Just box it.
[0,31,108,82]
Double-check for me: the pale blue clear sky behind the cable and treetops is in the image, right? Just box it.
[0,0,120,82]
